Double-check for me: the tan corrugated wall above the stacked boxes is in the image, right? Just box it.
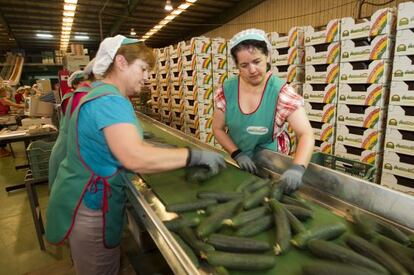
[204,0,407,39]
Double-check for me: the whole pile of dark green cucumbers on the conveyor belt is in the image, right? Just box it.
[165,179,414,275]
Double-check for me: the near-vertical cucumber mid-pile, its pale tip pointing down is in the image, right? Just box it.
[269,199,292,255]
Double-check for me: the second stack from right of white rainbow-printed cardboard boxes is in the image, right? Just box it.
[335,8,396,182]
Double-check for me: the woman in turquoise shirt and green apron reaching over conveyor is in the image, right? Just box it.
[46,35,225,275]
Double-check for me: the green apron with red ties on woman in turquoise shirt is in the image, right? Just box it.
[45,84,143,248]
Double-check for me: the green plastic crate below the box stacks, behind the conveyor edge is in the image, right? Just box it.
[311,152,377,182]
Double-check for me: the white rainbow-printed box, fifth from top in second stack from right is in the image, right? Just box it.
[337,104,387,130]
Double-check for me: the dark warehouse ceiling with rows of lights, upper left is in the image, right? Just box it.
[0,0,263,52]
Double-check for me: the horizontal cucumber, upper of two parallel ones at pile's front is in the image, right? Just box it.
[207,234,270,253]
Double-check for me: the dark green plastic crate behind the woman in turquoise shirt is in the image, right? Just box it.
[26,140,55,178]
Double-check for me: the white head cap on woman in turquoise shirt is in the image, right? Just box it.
[93,34,138,75]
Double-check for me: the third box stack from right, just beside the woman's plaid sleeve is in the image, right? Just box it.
[303,19,341,154]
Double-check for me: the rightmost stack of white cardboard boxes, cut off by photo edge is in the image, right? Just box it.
[381,2,414,194]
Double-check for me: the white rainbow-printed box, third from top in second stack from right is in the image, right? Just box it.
[339,59,392,84]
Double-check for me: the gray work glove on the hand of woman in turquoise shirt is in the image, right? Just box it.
[187,149,226,174]
